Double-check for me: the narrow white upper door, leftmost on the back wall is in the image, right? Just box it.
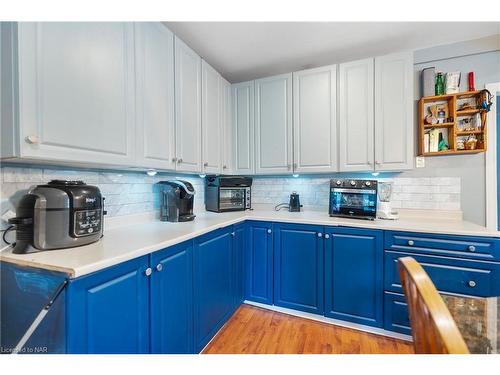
[231,81,254,174]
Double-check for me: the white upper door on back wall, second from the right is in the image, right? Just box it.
[339,59,374,172]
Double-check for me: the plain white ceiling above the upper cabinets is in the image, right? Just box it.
[165,22,500,83]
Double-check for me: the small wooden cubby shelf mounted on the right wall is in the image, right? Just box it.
[418,91,487,156]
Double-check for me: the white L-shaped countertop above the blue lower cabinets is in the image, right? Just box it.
[0,210,500,278]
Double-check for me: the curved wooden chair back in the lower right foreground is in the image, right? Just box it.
[398,257,469,354]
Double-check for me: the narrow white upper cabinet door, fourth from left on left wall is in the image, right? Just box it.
[201,60,222,173]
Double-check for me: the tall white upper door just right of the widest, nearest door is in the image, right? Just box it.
[135,22,175,170]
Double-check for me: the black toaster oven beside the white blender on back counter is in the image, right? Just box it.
[329,180,377,220]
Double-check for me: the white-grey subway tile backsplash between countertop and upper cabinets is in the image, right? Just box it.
[0,165,461,231]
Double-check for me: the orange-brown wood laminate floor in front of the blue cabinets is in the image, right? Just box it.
[203,305,413,354]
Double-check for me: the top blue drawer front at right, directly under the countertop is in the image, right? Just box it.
[384,231,500,261]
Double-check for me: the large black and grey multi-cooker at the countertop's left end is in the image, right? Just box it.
[9,180,105,254]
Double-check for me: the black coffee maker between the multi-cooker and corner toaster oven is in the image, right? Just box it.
[158,180,196,222]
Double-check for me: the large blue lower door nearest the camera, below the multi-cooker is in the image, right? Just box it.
[66,256,150,353]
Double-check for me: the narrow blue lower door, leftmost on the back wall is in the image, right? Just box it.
[245,221,273,305]
